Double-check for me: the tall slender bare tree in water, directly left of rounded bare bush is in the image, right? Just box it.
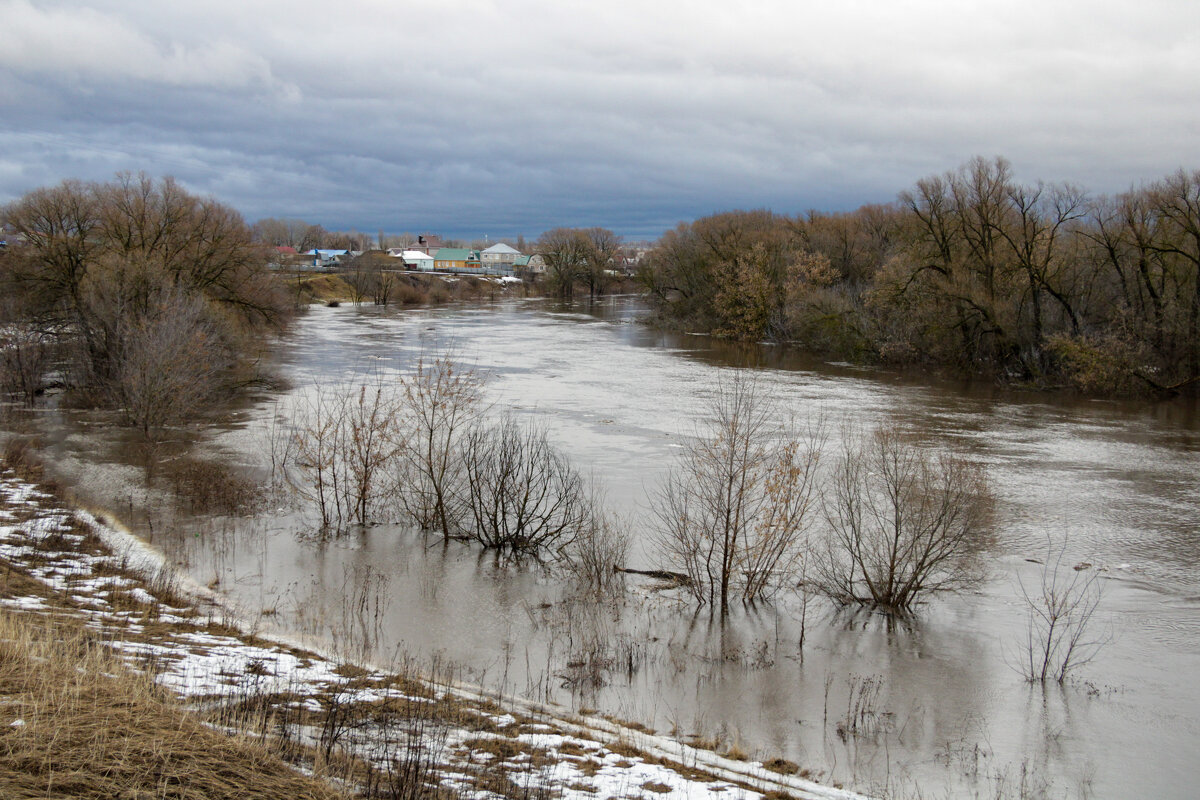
[652,373,820,615]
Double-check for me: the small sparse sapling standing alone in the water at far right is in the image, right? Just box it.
[1018,543,1108,684]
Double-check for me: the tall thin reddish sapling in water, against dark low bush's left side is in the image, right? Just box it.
[397,353,484,537]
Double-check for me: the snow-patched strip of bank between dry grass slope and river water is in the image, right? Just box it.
[0,473,862,800]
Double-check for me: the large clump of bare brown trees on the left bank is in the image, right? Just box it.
[0,174,292,434]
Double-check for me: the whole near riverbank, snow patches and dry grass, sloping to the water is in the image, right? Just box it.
[0,453,858,800]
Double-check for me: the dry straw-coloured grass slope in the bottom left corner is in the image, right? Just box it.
[0,610,347,800]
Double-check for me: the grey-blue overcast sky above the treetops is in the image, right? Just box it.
[0,0,1200,237]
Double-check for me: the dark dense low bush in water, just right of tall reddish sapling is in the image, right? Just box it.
[462,416,589,558]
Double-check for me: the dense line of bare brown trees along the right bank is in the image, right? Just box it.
[641,157,1200,395]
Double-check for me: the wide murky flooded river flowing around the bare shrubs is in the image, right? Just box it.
[11,299,1200,798]
